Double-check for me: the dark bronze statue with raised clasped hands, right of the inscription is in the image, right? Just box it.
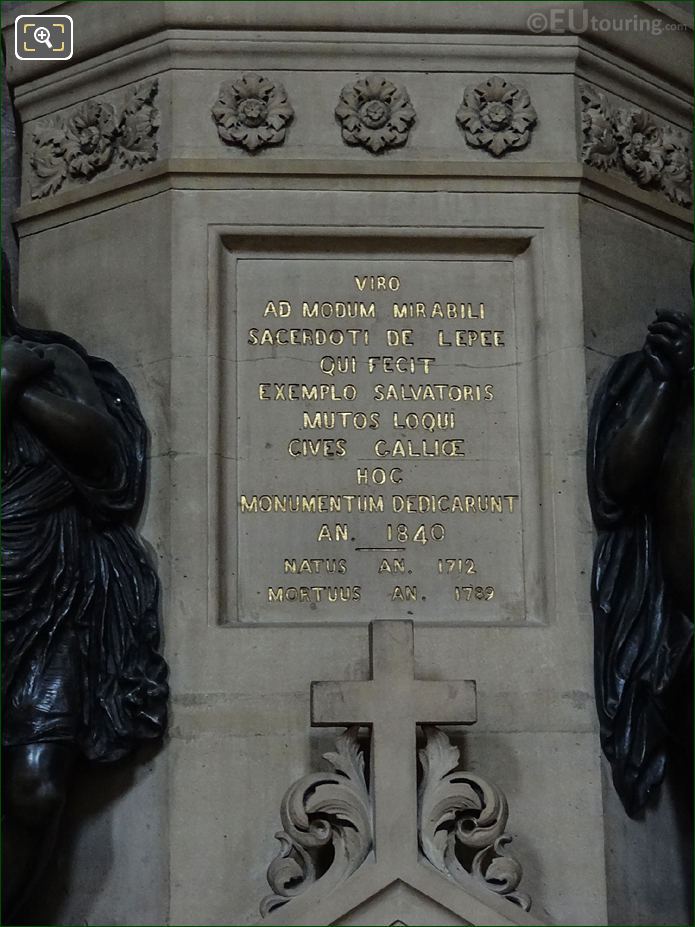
[588,312,693,817]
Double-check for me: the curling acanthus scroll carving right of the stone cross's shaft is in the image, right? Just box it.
[418,725,531,911]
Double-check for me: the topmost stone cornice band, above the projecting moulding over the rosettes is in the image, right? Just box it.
[2,0,692,93]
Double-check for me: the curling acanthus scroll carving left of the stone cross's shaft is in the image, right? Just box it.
[260,727,373,917]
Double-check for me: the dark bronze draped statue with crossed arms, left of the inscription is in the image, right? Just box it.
[2,254,168,923]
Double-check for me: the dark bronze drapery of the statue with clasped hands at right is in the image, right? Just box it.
[587,352,692,816]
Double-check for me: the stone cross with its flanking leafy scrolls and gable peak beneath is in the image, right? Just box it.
[261,620,542,927]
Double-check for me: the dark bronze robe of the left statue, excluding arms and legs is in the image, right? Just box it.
[2,352,168,762]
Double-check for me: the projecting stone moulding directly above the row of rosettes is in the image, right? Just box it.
[8,29,692,128]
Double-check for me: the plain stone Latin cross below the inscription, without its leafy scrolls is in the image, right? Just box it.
[311,620,477,864]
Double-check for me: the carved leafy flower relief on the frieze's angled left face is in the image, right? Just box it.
[29,79,159,199]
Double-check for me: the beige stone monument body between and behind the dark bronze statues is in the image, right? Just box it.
[3,0,692,924]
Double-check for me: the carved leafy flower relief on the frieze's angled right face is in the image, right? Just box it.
[581,86,693,206]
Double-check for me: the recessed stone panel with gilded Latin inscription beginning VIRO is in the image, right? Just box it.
[223,257,525,623]
